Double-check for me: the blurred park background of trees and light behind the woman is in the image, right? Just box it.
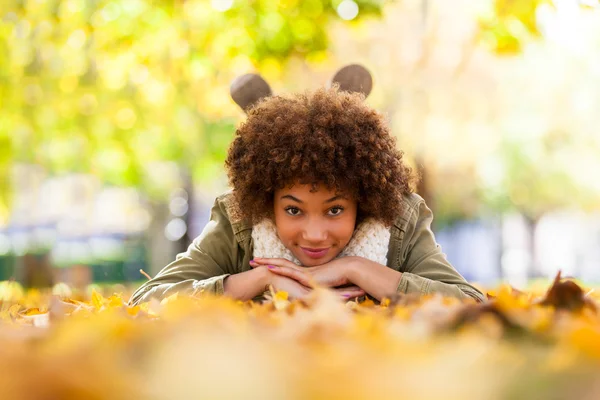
[0,0,600,286]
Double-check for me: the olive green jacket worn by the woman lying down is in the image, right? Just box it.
[130,192,483,304]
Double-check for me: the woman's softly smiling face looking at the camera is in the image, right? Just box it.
[274,184,357,267]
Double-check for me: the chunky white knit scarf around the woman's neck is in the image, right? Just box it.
[252,218,390,265]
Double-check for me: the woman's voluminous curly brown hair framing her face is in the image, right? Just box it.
[225,87,416,226]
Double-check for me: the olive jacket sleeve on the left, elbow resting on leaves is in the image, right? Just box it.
[129,197,239,305]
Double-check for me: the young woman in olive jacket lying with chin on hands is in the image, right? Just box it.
[131,67,483,304]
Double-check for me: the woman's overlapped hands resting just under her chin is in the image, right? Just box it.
[250,258,365,299]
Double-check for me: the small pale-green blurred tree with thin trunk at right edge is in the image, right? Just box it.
[481,130,599,277]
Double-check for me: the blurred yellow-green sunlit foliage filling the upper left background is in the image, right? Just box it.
[0,0,383,222]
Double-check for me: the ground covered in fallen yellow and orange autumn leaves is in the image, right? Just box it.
[0,277,600,400]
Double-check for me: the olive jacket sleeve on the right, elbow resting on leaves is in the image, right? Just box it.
[397,200,484,301]
